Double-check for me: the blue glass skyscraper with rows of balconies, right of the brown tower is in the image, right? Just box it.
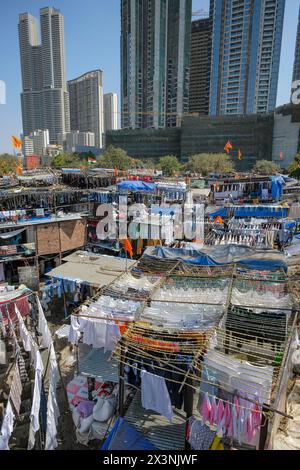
[210,0,285,115]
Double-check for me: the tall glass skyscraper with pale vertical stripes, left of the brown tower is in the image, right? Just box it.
[121,0,192,129]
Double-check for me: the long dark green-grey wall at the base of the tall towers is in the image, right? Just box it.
[107,105,300,171]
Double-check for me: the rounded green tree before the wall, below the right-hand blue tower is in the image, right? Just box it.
[184,153,235,176]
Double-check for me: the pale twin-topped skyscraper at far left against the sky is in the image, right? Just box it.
[19,7,70,143]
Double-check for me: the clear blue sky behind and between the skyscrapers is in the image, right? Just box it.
[0,0,300,153]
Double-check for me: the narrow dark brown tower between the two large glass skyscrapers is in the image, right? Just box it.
[189,18,212,115]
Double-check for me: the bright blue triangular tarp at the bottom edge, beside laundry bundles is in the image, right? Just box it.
[100,416,157,450]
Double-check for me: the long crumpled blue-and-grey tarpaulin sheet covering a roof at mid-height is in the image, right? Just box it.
[143,245,287,271]
